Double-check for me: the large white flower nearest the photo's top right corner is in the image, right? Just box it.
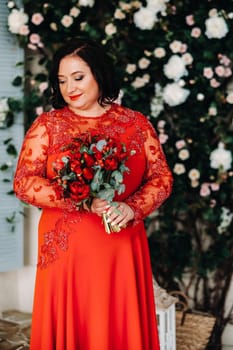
[205,16,229,39]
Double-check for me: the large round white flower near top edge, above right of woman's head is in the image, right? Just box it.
[133,7,157,30]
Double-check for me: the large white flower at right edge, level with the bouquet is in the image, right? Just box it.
[210,142,232,171]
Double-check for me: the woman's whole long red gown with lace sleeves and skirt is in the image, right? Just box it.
[14,104,172,350]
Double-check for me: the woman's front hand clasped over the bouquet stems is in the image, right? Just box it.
[107,202,134,227]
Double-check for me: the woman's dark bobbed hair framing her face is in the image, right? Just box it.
[50,38,119,108]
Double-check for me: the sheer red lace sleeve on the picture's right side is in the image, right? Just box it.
[126,123,173,223]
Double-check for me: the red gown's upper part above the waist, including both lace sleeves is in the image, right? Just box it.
[14,104,172,222]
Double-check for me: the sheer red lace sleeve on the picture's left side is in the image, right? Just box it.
[14,114,74,210]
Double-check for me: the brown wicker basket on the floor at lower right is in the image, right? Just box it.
[171,292,216,350]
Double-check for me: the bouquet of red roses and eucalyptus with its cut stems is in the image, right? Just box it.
[53,132,132,233]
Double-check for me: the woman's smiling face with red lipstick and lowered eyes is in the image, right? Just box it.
[58,56,102,116]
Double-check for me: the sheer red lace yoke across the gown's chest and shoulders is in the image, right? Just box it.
[41,104,148,154]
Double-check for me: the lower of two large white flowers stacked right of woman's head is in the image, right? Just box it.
[163,83,190,107]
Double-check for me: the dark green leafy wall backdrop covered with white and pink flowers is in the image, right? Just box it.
[7,0,233,349]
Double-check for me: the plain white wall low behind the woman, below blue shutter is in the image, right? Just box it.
[0,207,233,346]
